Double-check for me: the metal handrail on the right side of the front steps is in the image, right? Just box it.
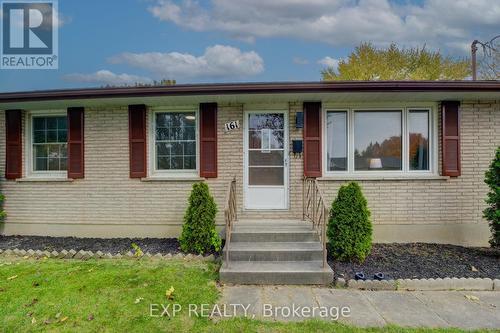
[302,177,329,268]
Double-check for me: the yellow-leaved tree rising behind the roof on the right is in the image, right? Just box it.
[321,43,471,81]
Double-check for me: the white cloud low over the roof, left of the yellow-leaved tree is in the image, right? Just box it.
[109,44,264,80]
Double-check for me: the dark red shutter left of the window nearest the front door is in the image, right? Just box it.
[128,104,147,178]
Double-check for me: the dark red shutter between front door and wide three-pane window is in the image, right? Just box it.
[304,102,321,177]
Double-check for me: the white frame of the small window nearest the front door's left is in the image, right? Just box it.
[148,106,200,178]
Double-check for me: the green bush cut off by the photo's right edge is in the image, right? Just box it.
[483,147,500,247]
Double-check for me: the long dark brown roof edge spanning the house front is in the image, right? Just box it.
[0,81,500,103]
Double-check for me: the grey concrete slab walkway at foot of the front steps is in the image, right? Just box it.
[219,286,500,329]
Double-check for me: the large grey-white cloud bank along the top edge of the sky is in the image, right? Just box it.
[149,0,500,52]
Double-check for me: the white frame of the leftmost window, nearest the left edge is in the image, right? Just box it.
[24,110,69,179]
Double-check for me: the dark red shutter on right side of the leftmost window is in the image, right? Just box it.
[68,107,85,179]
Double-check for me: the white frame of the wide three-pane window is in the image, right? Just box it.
[322,105,438,178]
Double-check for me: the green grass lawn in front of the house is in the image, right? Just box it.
[0,257,494,333]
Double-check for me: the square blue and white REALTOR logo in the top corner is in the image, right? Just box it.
[0,0,58,69]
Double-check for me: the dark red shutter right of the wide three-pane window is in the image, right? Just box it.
[441,102,460,177]
